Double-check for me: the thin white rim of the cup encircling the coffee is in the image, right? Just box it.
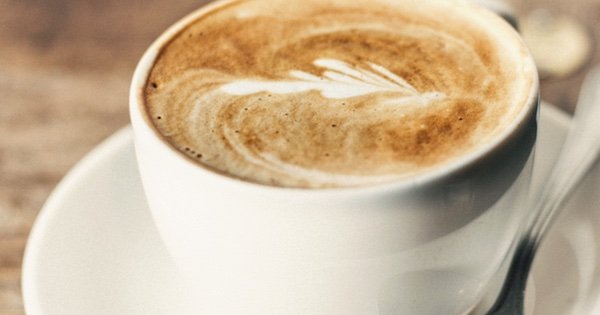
[129,0,539,194]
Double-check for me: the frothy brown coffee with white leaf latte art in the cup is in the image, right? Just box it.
[143,0,536,188]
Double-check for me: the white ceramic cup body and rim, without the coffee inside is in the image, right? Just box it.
[130,2,538,315]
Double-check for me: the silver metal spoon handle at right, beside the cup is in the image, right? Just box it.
[488,66,600,315]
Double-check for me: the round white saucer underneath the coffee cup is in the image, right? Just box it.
[22,106,600,315]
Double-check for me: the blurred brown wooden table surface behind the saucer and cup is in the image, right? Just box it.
[0,0,600,315]
